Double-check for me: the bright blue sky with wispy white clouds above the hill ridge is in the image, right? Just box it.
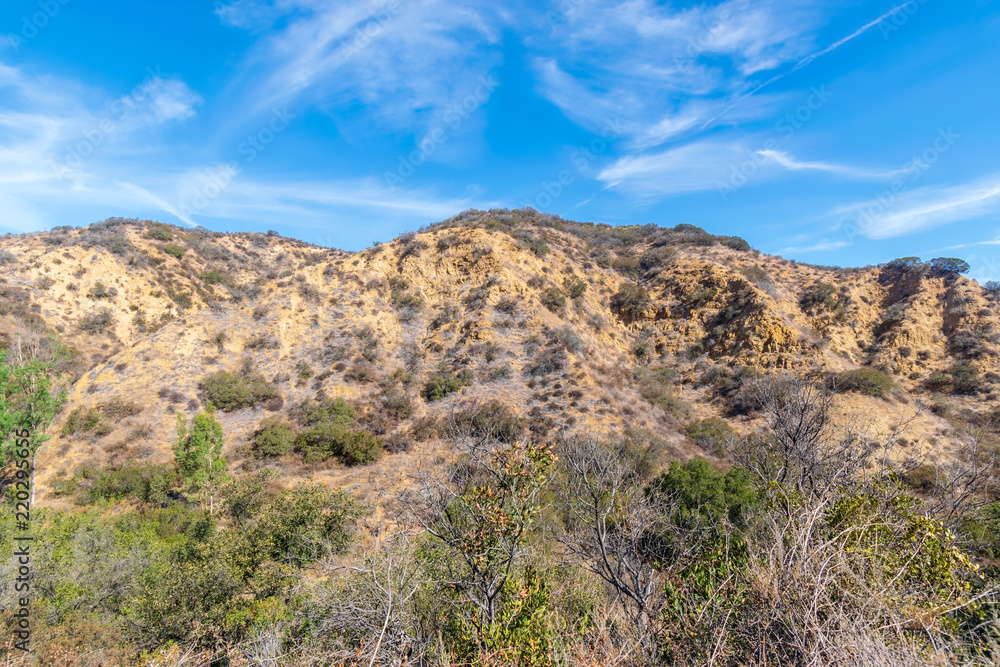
[0,0,1000,280]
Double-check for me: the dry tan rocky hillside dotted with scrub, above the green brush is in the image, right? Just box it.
[0,210,1000,505]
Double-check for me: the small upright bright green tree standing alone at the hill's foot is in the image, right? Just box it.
[174,403,228,512]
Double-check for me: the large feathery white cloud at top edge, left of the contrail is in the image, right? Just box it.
[230,0,506,134]
